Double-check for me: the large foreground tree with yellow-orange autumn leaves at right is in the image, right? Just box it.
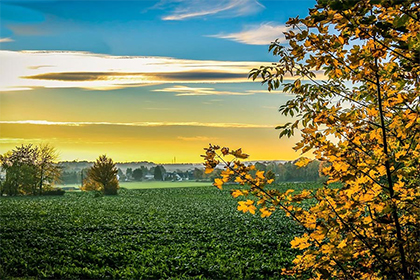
[205,0,420,279]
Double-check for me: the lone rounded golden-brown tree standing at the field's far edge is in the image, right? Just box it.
[83,155,120,195]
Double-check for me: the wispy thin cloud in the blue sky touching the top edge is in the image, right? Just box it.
[158,0,264,20]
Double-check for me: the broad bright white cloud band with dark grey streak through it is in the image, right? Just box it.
[0,51,269,91]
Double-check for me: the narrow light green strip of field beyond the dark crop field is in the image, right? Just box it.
[57,181,212,190]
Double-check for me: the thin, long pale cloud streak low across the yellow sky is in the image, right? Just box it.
[0,120,274,128]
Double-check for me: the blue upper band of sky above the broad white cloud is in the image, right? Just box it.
[1,0,314,61]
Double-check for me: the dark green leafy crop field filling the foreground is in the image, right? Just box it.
[0,184,316,279]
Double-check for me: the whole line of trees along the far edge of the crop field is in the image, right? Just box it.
[0,144,321,195]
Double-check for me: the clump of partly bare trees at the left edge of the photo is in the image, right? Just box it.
[0,144,61,195]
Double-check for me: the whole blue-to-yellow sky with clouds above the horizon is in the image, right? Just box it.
[0,0,315,163]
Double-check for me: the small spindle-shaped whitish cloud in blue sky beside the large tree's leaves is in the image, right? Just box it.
[207,23,289,45]
